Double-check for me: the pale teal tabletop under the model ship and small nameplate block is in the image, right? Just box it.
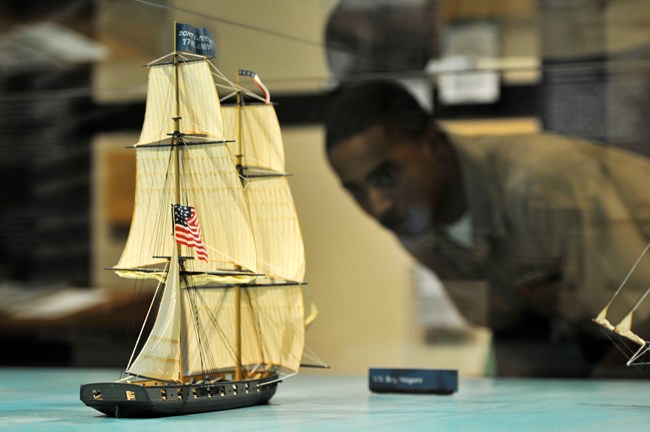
[0,369,650,432]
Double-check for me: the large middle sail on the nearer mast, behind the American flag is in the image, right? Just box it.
[115,144,256,283]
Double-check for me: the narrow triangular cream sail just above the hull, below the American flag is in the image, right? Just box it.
[127,246,181,382]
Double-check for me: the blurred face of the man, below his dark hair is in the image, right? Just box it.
[328,125,446,236]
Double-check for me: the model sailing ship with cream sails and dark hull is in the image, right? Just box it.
[80,24,313,417]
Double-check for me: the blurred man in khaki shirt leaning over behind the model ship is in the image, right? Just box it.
[326,81,650,376]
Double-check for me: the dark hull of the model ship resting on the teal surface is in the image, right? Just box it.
[80,376,278,417]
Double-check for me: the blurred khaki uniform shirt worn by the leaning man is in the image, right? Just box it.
[400,134,650,328]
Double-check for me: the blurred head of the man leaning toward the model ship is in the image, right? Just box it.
[326,81,452,236]
